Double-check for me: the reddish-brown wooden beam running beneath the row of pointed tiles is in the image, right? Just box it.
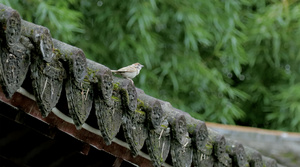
[0,89,152,166]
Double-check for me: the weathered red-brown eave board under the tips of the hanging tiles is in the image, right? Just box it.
[0,88,155,167]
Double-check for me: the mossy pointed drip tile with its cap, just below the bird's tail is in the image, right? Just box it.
[87,60,123,145]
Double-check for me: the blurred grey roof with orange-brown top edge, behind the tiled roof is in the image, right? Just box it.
[206,122,300,167]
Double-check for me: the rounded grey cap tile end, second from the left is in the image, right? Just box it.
[21,20,54,63]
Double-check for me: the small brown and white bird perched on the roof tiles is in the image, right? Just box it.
[111,63,144,81]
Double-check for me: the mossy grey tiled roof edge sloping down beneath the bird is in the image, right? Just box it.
[0,4,280,167]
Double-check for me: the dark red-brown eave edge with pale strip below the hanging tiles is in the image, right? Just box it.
[0,87,166,167]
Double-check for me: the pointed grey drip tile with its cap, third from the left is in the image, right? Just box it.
[52,39,91,129]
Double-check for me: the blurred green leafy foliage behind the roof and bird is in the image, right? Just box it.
[0,0,300,132]
